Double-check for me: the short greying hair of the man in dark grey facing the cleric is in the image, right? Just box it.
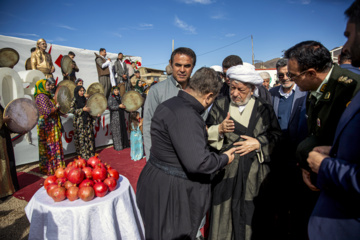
[188,67,222,95]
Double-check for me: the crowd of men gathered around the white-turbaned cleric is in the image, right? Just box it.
[137,0,360,239]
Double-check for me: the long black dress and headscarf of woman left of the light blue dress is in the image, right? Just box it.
[108,89,130,151]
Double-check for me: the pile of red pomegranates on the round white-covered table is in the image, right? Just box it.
[44,154,119,202]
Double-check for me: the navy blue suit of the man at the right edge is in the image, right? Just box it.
[309,90,360,240]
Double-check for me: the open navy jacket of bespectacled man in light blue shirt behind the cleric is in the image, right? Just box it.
[269,86,307,145]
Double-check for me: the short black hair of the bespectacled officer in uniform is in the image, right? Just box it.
[284,41,332,72]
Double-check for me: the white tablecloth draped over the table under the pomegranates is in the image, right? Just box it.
[25,176,144,240]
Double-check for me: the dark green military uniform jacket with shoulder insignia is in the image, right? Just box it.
[297,62,360,170]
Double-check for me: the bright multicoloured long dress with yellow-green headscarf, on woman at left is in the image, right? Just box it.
[34,79,65,175]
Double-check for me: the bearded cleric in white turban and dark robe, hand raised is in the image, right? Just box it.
[206,63,281,240]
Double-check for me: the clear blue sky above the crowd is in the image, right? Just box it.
[0,0,353,69]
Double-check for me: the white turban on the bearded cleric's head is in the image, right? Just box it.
[226,63,264,86]
